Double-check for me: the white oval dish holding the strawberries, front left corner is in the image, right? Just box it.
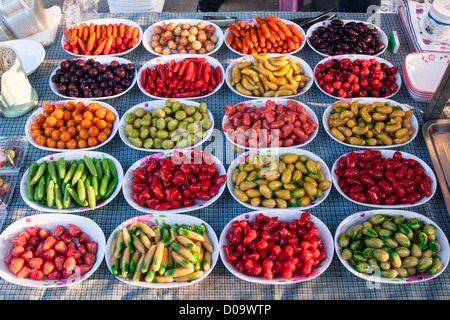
[0,214,106,289]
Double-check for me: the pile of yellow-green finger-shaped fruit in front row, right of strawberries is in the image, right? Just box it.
[111,222,214,283]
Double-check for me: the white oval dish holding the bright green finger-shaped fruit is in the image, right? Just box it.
[20,150,123,213]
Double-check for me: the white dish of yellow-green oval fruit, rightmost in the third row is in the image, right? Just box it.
[322,98,419,149]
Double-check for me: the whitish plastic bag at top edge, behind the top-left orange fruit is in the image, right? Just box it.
[62,0,100,27]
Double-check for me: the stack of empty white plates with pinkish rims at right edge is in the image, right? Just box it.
[403,51,450,102]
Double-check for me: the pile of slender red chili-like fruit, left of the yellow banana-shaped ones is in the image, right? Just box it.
[140,58,223,99]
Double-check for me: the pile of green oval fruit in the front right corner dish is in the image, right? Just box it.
[338,214,443,278]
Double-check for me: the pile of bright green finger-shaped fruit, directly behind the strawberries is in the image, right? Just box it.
[26,156,119,210]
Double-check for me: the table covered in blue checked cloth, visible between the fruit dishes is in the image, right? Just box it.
[0,12,450,300]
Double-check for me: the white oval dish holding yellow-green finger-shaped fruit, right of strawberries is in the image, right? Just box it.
[105,212,219,289]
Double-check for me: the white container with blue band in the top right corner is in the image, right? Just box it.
[422,0,450,42]
